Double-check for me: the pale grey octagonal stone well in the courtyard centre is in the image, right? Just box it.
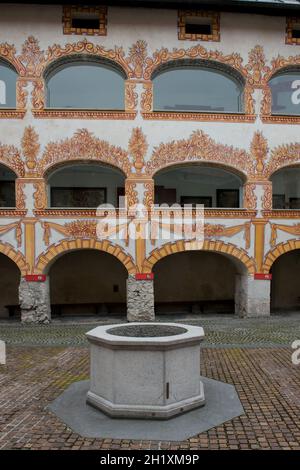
[87,322,205,419]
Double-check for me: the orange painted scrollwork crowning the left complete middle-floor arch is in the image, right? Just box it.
[37,129,131,176]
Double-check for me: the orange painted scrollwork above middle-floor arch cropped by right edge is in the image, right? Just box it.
[265,142,300,177]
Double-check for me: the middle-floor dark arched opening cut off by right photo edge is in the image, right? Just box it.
[271,167,300,209]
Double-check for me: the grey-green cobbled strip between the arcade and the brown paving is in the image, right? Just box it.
[0,313,300,347]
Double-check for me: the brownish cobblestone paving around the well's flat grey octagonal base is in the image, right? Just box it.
[0,346,300,450]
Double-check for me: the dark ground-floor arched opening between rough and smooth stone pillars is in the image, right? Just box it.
[153,251,246,314]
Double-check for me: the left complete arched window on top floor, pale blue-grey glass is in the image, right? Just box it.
[45,58,126,110]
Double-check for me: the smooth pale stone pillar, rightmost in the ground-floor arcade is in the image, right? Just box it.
[235,274,271,318]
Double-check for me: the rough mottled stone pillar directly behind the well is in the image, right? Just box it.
[127,275,155,321]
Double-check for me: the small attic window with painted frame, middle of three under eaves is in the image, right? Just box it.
[178,10,220,41]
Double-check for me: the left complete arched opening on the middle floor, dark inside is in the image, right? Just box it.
[48,163,125,208]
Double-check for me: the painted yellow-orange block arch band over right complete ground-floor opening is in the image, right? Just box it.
[143,240,256,274]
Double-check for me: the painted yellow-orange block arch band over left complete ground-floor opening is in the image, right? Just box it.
[35,238,137,274]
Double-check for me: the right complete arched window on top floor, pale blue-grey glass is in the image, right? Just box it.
[153,61,244,113]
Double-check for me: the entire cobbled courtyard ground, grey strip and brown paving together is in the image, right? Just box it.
[0,313,300,450]
